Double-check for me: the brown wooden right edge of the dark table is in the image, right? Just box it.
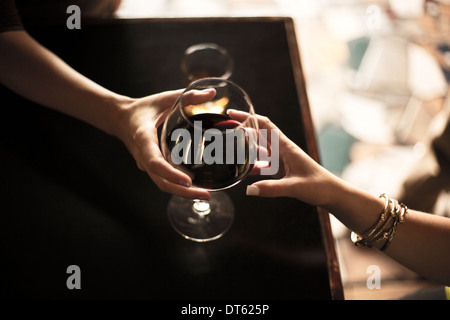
[285,18,344,300]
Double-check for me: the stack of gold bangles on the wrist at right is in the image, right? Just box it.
[351,193,408,251]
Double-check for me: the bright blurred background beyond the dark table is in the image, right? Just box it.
[117,0,450,300]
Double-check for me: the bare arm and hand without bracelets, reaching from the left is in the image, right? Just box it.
[0,31,209,199]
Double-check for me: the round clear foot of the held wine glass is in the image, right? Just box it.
[167,191,234,242]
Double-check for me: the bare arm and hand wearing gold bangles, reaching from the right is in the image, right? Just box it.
[243,115,450,285]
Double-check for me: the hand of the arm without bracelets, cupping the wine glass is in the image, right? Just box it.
[113,90,215,200]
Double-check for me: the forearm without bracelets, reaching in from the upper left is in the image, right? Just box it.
[0,31,131,137]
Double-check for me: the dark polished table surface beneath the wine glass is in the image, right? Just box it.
[0,18,343,299]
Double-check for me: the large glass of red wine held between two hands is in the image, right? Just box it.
[161,78,258,242]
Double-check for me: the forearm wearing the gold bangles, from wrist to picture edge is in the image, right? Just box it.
[324,175,450,285]
